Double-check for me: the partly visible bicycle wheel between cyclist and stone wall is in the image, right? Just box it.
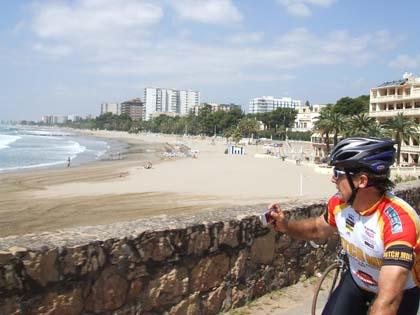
[310,242,348,315]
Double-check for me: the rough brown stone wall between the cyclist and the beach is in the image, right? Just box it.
[0,181,420,315]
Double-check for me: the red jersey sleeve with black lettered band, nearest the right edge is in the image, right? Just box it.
[382,204,419,269]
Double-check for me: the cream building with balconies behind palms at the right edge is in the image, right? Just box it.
[369,73,420,165]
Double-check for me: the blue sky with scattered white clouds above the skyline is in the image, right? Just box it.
[0,0,420,120]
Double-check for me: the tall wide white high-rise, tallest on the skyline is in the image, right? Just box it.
[144,87,200,120]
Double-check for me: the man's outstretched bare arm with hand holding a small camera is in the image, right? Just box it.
[268,204,336,240]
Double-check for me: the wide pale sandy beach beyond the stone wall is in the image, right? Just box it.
[0,131,335,237]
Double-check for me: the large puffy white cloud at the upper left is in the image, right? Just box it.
[31,0,163,48]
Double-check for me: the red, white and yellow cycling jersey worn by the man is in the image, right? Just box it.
[324,192,420,293]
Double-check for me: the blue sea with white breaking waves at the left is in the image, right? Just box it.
[0,125,111,173]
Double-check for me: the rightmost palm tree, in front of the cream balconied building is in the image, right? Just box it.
[382,113,419,165]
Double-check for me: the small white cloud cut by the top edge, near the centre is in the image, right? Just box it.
[170,0,243,24]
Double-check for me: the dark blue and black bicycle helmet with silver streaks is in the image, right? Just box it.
[329,137,396,174]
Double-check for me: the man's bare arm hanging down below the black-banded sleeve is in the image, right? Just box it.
[369,265,410,315]
